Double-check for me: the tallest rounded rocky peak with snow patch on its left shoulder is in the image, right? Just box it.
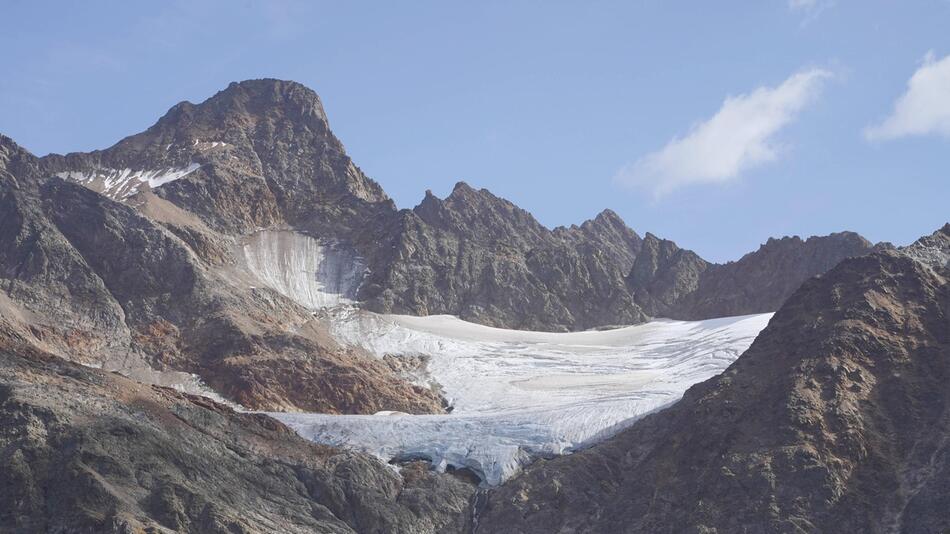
[36,79,396,234]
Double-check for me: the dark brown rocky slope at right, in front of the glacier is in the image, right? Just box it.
[478,226,950,533]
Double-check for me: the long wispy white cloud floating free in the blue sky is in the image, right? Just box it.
[615,69,831,197]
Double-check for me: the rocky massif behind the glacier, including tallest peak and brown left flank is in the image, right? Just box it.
[0,80,880,413]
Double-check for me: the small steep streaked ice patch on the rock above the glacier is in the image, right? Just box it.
[243,230,366,310]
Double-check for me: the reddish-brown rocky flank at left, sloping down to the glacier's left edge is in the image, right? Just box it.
[0,133,442,413]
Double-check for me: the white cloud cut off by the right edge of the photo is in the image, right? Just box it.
[864,51,950,141]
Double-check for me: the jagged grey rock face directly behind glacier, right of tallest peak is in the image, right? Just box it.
[363,183,645,330]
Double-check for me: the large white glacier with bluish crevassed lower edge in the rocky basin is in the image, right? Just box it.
[271,309,772,485]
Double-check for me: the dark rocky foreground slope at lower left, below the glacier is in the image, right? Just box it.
[0,340,476,534]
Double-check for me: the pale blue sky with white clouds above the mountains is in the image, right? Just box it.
[0,0,950,262]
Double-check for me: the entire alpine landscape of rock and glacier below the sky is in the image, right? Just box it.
[0,79,950,533]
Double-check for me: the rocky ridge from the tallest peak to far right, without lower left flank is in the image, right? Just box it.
[26,79,870,330]
